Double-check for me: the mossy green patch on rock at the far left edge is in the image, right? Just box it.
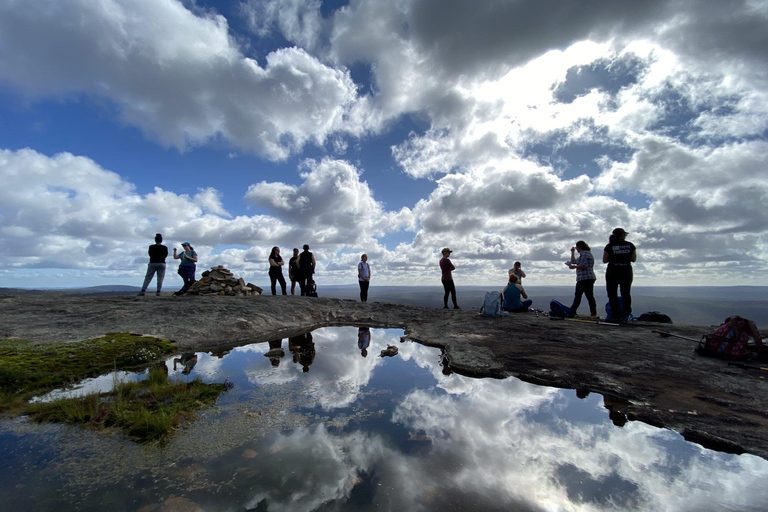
[0,333,174,411]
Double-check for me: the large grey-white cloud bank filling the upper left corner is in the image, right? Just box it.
[0,0,356,160]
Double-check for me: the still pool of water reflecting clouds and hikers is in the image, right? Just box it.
[0,327,768,512]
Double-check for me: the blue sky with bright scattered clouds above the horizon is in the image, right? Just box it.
[0,0,768,287]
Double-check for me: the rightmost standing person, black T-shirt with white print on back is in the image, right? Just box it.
[603,228,637,321]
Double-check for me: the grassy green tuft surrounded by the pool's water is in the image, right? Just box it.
[24,367,227,443]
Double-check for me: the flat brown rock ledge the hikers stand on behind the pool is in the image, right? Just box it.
[0,295,768,459]
